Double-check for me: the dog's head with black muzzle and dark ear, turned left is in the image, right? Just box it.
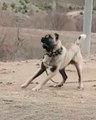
[41,33,59,52]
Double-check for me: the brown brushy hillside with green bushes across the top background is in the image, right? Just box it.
[0,0,96,32]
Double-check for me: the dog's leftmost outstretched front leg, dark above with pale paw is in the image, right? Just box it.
[21,63,46,88]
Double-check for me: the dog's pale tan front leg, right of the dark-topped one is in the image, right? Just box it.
[32,70,58,91]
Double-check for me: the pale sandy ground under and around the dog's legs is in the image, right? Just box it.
[0,56,96,120]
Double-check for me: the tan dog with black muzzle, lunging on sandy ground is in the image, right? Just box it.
[21,33,86,91]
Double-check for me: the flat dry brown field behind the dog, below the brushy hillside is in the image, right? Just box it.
[0,27,96,61]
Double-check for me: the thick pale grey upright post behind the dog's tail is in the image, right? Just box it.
[82,0,93,56]
